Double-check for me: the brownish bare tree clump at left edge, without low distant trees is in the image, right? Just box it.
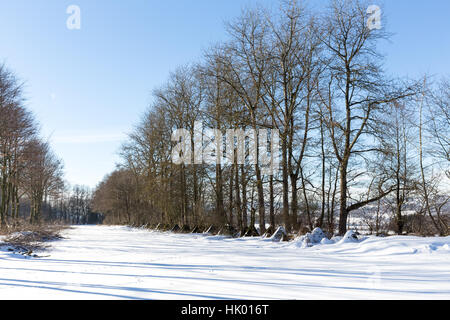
[0,65,64,228]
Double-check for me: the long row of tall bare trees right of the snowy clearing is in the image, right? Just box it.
[93,0,450,235]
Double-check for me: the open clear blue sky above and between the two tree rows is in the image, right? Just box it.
[0,0,450,187]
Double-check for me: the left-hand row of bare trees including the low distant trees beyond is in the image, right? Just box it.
[0,65,102,229]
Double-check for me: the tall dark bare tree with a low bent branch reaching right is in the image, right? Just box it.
[321,0,415,235]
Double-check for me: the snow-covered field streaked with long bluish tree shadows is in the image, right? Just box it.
[0,226,450,299]
